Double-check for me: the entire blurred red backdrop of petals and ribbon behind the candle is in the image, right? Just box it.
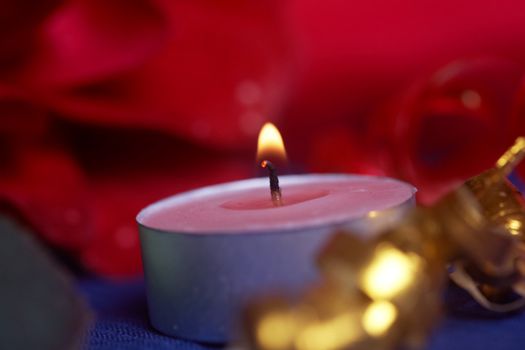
[0,0,525,276]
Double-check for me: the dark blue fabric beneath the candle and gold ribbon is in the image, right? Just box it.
[79,279,525,350]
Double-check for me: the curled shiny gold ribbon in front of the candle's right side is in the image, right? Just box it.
[239,137,525,350]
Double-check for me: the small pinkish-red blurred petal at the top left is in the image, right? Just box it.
[19,0,168,87]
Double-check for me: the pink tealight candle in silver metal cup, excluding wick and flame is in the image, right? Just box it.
[137,175,415,343]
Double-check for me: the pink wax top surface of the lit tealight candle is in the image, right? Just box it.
[138,175,415,234]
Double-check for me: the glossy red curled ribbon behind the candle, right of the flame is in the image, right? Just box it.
[375,58,523,202]
